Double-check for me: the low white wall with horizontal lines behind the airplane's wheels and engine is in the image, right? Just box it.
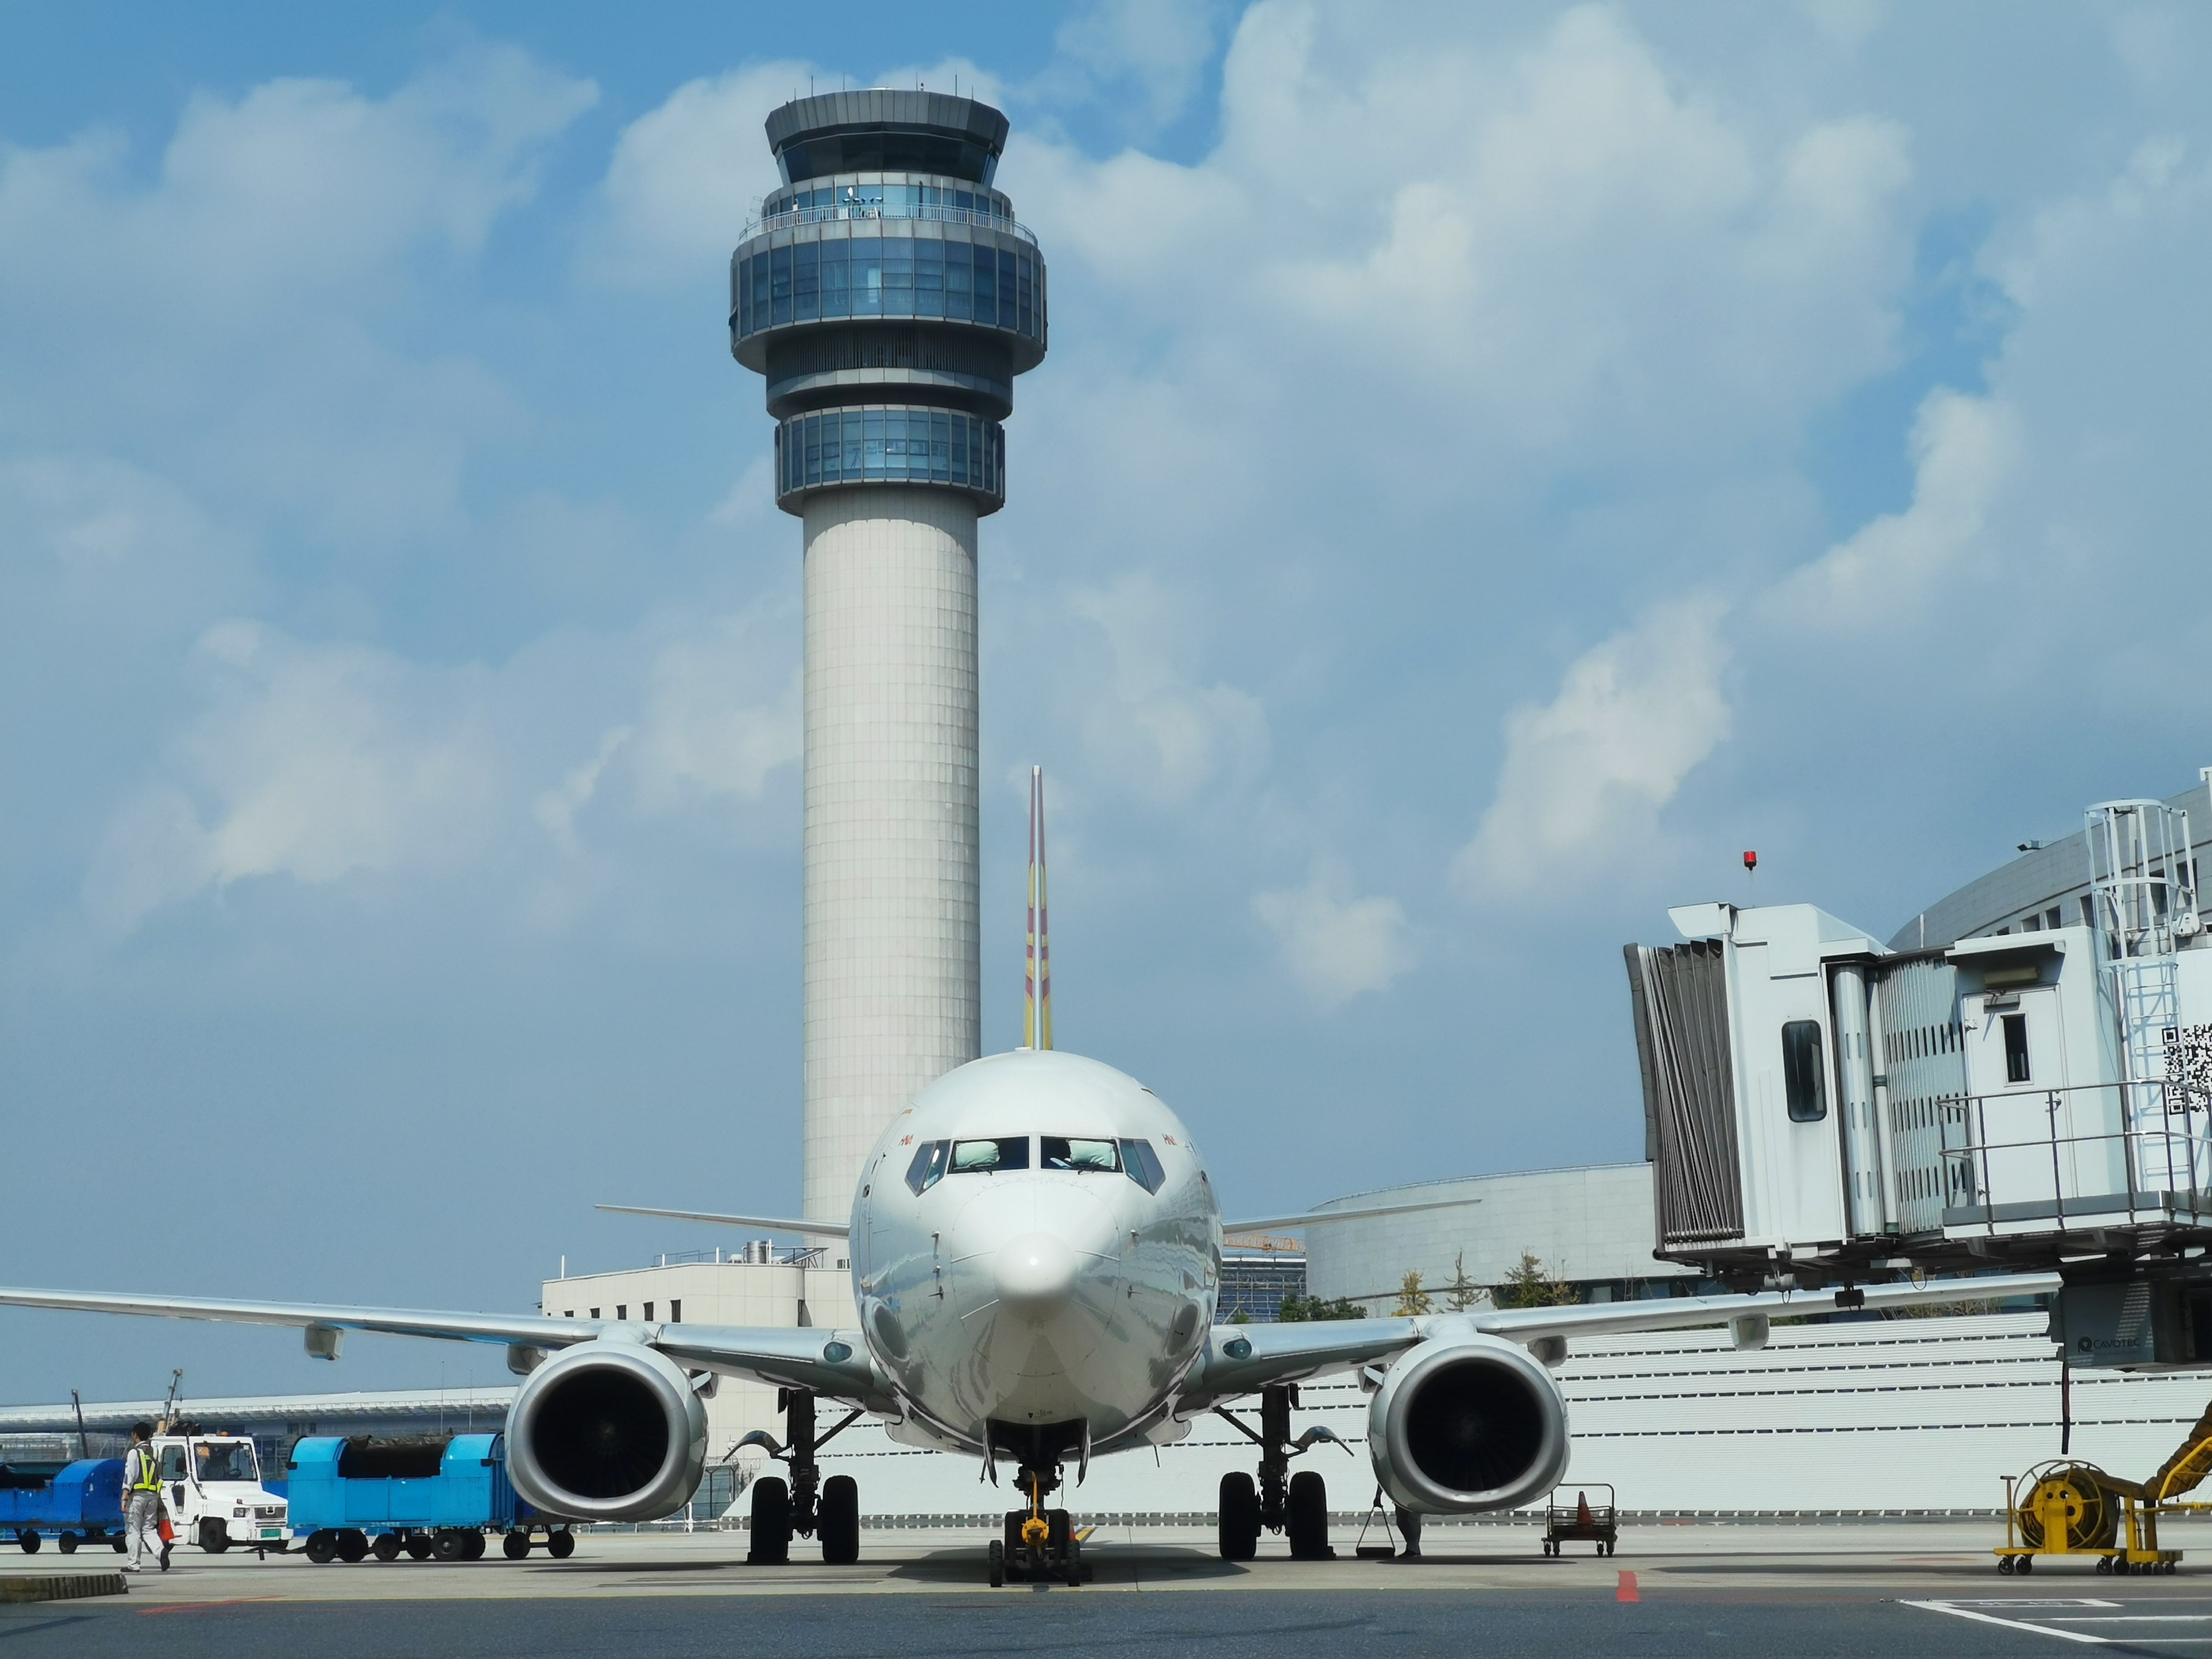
[825,1314,2212,1518]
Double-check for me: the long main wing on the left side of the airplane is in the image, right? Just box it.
[0,1290,896,1411]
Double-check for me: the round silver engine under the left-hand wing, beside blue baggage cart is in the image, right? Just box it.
[506,1338,706,1522]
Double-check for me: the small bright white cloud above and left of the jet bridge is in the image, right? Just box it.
[1453,600,1730,894]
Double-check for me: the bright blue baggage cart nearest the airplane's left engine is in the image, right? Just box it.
[286,1433,575,1564]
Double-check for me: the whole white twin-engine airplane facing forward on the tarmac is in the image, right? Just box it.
[0,776,2059,1586]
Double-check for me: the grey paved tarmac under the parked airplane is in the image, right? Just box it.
[13,1522,2212,1659]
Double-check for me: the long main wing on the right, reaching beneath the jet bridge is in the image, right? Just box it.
[1177,1274,2059,1416]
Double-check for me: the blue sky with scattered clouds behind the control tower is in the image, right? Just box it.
[0,0,2212,1398]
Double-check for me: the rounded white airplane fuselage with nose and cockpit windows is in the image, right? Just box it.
[851,1048,1221,1451]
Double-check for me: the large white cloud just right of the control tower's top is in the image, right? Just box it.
[1026,4,1911,469]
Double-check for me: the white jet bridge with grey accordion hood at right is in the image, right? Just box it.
[1626,801,2212,1369]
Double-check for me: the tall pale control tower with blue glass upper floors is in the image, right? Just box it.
[730,91,1044,1221]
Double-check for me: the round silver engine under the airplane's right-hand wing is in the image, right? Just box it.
[1367,1334,1566,1515]
